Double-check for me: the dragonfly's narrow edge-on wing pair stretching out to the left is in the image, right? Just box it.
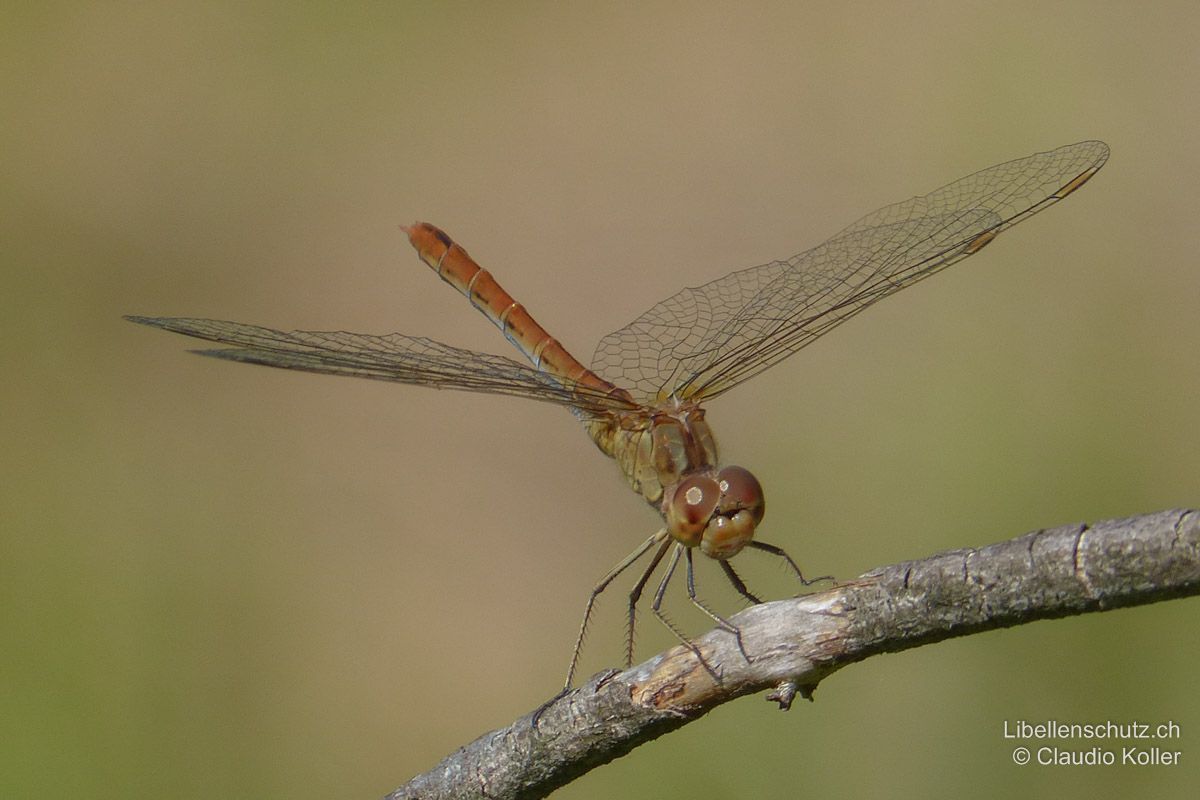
[126,317,632,414]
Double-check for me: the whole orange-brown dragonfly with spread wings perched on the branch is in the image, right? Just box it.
[126,140,1109,691]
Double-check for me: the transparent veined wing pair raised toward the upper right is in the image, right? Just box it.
[592,142,1109,404]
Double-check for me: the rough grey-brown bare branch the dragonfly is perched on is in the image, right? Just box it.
[388,510,1200,800]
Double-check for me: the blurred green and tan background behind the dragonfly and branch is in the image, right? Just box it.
[0,2,1200,800]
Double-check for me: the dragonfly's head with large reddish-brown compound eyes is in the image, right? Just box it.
[664,467,766,561]
